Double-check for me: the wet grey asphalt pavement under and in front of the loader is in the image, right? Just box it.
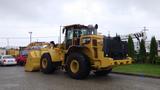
[0,66,160,90]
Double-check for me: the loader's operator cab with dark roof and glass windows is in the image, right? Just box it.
[63,24,98,49]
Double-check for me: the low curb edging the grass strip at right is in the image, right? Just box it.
[111,72,160,79]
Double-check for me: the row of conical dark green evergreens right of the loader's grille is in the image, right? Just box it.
[128,36,160,64]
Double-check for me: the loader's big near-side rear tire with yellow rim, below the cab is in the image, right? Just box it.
[66,53,90,79]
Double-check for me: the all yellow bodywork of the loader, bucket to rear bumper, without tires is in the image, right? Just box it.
[25,35,132,71]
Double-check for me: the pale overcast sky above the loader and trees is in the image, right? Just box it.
[0,0,160,46]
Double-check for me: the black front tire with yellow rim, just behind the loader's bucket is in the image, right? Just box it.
[40,53,56,74]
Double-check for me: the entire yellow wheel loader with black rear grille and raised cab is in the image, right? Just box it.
[25,24,132,79]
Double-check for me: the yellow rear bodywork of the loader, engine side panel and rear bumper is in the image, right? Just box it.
[81,35,132,69]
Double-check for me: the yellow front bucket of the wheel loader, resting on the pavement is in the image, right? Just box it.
[25,50,41,72]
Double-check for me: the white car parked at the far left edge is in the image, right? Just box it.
[0,55,17,65]
